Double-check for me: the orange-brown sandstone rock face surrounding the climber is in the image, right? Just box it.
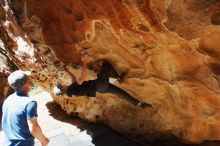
[0,0,220,143]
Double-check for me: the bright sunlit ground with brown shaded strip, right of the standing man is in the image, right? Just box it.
[30,92,92,143]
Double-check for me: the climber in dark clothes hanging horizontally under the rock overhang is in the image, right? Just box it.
[54,55,152,108]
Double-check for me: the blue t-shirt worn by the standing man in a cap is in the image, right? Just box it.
[2,93,38,146]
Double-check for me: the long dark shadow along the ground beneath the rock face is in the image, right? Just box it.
[46,102,220,146]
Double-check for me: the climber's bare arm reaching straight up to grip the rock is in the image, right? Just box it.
[76,55,88,85]
